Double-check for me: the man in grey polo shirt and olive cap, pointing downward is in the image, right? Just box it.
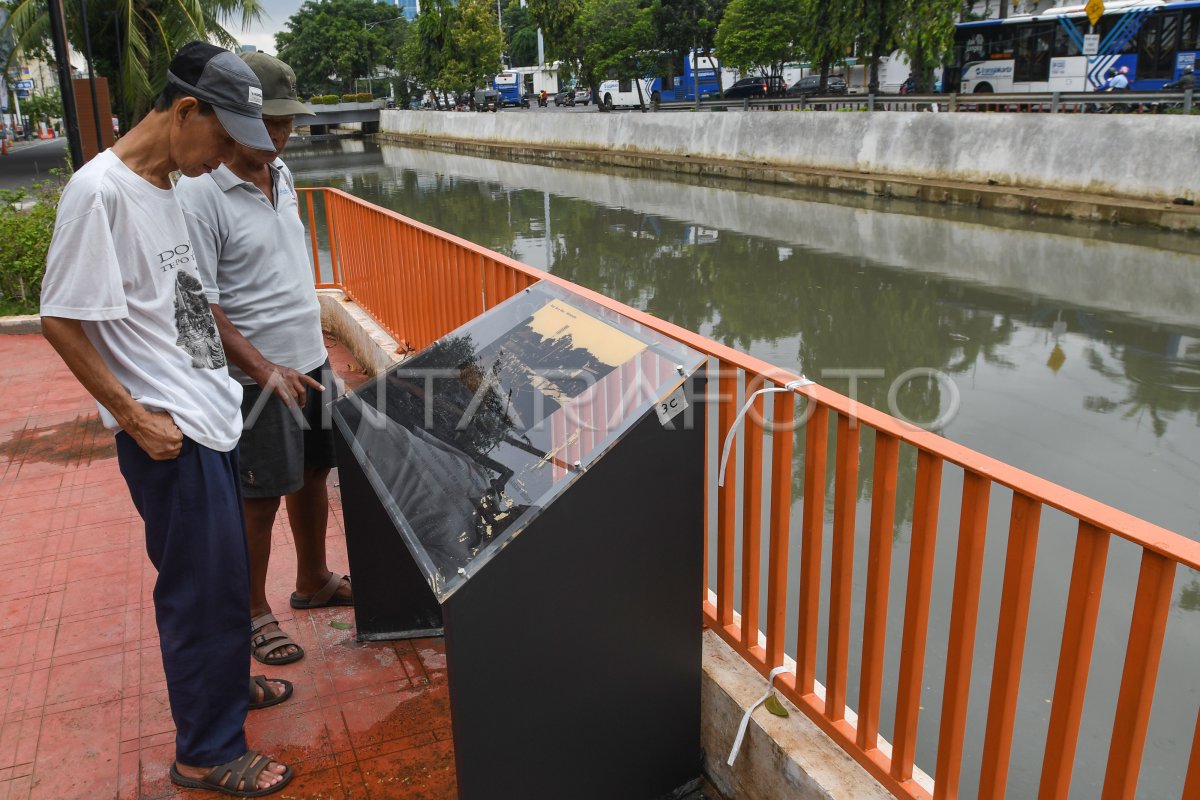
[178,53,353,664]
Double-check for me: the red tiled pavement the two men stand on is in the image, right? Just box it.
[0,336,456,800]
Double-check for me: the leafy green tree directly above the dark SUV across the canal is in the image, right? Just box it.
[716,0,804,76]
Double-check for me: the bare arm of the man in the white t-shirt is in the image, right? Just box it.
[42,317,184,461]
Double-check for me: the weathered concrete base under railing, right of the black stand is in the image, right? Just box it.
[701,631,892,800]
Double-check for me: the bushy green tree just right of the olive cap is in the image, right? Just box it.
[275,0,406,94]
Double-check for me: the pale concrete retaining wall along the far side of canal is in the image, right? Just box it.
[378,110,1200,231]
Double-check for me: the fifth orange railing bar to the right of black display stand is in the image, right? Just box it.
[826,415,860,722]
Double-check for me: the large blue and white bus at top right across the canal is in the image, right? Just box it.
[946,0,1200,95]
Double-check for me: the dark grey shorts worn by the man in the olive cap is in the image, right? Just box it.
[239,359,336,498]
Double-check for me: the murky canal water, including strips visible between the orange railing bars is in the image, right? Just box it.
[287,134,1200,798]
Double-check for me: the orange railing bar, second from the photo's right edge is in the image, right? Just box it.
[1100,551,1176,800]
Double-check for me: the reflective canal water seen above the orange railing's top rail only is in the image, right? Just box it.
[289,142,1200,535]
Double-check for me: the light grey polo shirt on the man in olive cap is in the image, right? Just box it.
[175,158,328,384]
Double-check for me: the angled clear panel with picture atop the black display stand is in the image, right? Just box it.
[334,281,704,602]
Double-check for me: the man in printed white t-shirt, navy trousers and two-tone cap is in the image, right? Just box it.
[41,42,292,796]
